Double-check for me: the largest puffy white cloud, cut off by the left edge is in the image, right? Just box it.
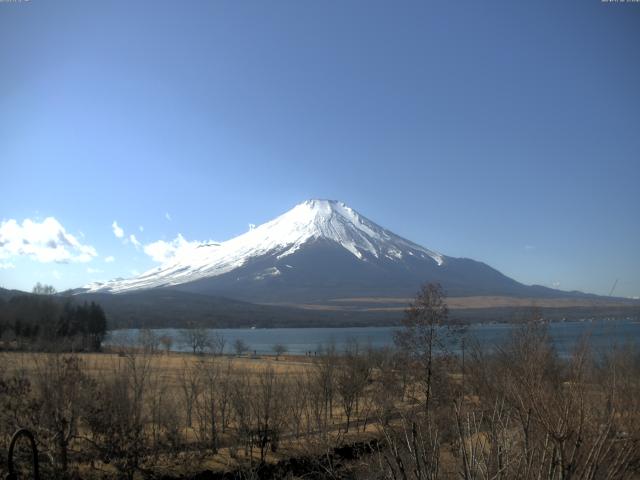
[0,217,98,263]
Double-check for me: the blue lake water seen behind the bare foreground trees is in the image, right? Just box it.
[104,318,640,355]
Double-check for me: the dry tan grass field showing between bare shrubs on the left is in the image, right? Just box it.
[0,351,384,478]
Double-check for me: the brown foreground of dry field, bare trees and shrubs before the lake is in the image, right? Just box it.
[0,287,640,480]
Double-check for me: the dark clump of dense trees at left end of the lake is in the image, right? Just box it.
[0,283,107,351]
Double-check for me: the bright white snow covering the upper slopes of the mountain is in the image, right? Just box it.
[85,200,446,293]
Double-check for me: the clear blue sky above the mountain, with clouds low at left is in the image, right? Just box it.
[0,0,640,296]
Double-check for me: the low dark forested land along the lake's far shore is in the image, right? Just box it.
[76,289,640,328]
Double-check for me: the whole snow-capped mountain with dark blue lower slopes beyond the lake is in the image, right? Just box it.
[83,200,570,305]
